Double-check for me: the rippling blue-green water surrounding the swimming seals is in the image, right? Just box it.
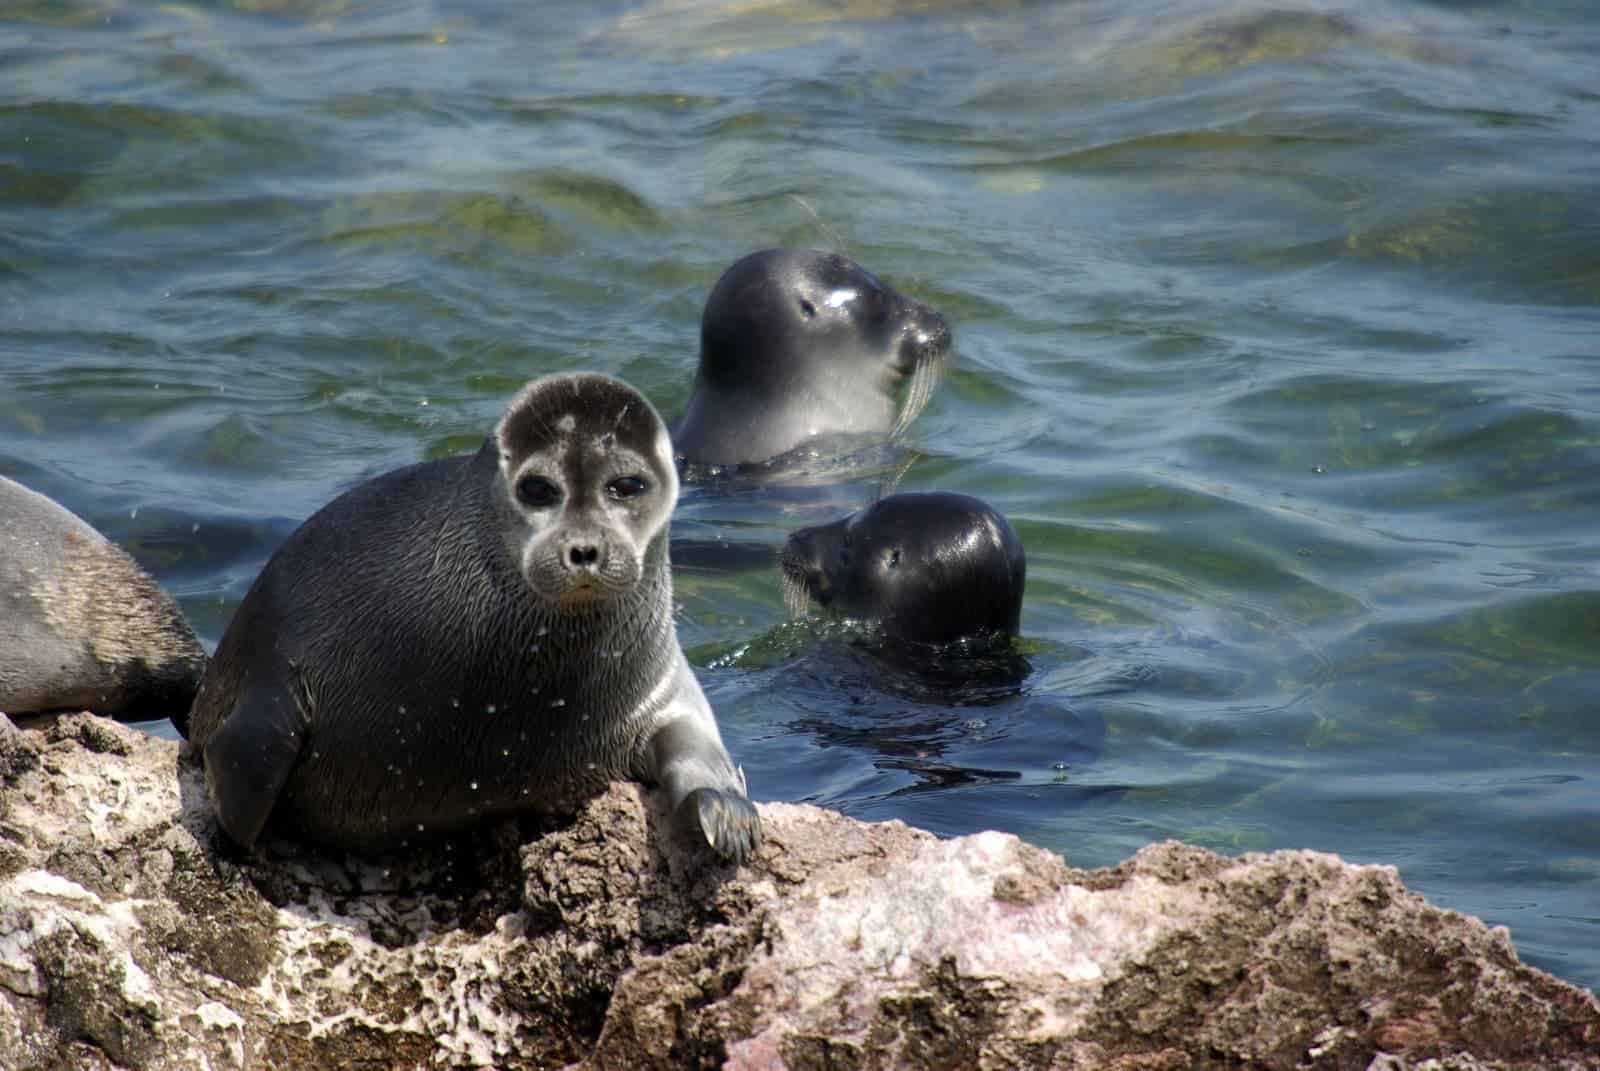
[0,0,1600,986]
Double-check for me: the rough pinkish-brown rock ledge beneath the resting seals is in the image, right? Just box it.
[0,716,1600,1071]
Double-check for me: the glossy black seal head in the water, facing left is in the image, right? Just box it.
[781,491,1027,644]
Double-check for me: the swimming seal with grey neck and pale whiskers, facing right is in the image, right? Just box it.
[672,250,950,466]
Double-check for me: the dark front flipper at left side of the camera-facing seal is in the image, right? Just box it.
[205,690,309,848]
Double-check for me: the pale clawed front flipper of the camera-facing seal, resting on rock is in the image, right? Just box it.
[650,717,762,863]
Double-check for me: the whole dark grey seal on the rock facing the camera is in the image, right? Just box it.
[190,373,760,861]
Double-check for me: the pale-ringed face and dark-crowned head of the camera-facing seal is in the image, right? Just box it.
[494,373,678,610]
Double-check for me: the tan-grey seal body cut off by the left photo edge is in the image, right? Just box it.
[0,477,205,722]
